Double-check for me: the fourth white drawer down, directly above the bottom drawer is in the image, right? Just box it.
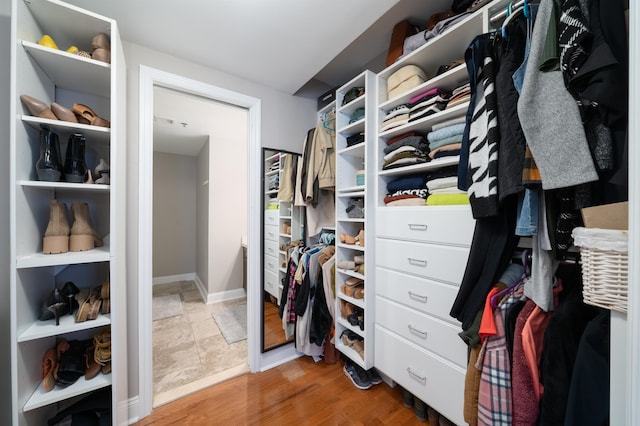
[375,297,467,368]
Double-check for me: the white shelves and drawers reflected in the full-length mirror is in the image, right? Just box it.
[263,149,303,305]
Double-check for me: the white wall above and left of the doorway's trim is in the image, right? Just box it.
[124,43,316,398]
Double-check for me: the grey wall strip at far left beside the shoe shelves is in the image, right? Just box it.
[0,7,11,425]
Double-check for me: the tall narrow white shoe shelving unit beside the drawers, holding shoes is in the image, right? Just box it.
[335,71,376,369]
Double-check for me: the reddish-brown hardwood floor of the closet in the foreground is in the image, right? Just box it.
[136,357,428,426]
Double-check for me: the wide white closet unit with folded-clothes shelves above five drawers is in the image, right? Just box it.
[374,6,487,424]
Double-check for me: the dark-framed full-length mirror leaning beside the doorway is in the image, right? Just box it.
[262,148,304,352]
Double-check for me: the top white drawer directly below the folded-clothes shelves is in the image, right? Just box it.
[376,206,475,246]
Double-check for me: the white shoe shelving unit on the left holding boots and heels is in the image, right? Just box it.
[10,0,128,425]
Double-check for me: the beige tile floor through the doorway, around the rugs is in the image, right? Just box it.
[153,281,249,406]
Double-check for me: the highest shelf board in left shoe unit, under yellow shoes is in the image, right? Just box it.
[22,40,111,98]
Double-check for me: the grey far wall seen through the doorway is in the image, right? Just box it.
[153,151,197,278]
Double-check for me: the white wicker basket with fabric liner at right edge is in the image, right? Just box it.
[572,227,629,313]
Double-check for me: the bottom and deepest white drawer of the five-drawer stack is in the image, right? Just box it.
[374,325,466,425]
